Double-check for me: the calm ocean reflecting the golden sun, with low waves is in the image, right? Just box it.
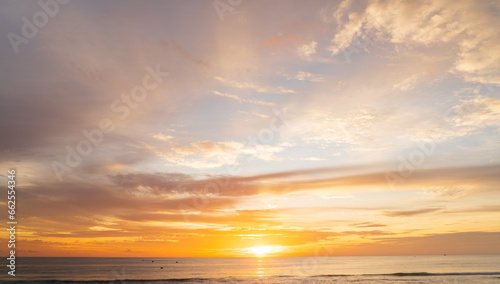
[0,255,500,284]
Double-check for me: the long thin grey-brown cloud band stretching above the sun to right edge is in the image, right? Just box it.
[110,162,500,196]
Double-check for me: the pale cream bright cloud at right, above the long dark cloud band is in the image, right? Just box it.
[288,92,500,152]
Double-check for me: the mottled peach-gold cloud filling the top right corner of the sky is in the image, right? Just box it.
[330,0,500,84]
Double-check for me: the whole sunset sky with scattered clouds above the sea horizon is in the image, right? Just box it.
[0,0,500,257]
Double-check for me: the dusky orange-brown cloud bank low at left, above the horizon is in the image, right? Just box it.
[17,182,239,237]
